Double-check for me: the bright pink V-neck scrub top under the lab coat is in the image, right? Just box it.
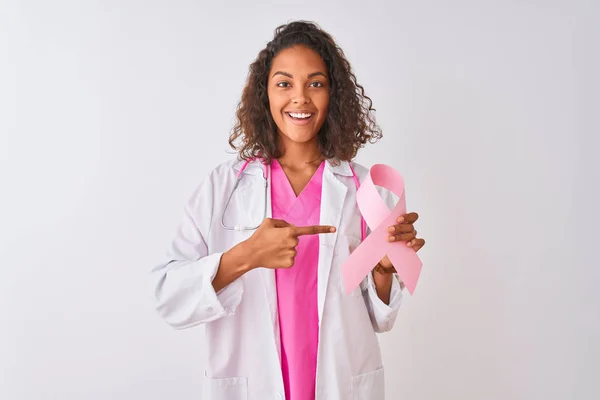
[271,160,325,400]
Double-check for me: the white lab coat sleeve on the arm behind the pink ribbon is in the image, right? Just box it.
[362,188,403,333]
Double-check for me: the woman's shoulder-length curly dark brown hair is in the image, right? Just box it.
[229,21,382,163]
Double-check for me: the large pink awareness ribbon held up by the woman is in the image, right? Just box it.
[342,164,423,295]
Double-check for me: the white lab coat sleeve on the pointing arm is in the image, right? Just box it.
[151,177,243,329]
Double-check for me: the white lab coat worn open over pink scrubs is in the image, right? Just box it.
[152,160,402,400]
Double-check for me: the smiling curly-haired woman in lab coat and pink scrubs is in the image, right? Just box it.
[153,21,425,400]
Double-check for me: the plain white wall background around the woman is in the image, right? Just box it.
[0,0,600,400]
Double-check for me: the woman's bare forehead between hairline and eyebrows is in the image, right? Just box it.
[271,46,327,77]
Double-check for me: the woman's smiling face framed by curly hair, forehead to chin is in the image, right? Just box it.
[267,46,329,145]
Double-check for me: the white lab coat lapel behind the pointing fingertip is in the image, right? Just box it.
[318,161,348,326]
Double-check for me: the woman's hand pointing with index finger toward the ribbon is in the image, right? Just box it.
[247,218,335,269]
